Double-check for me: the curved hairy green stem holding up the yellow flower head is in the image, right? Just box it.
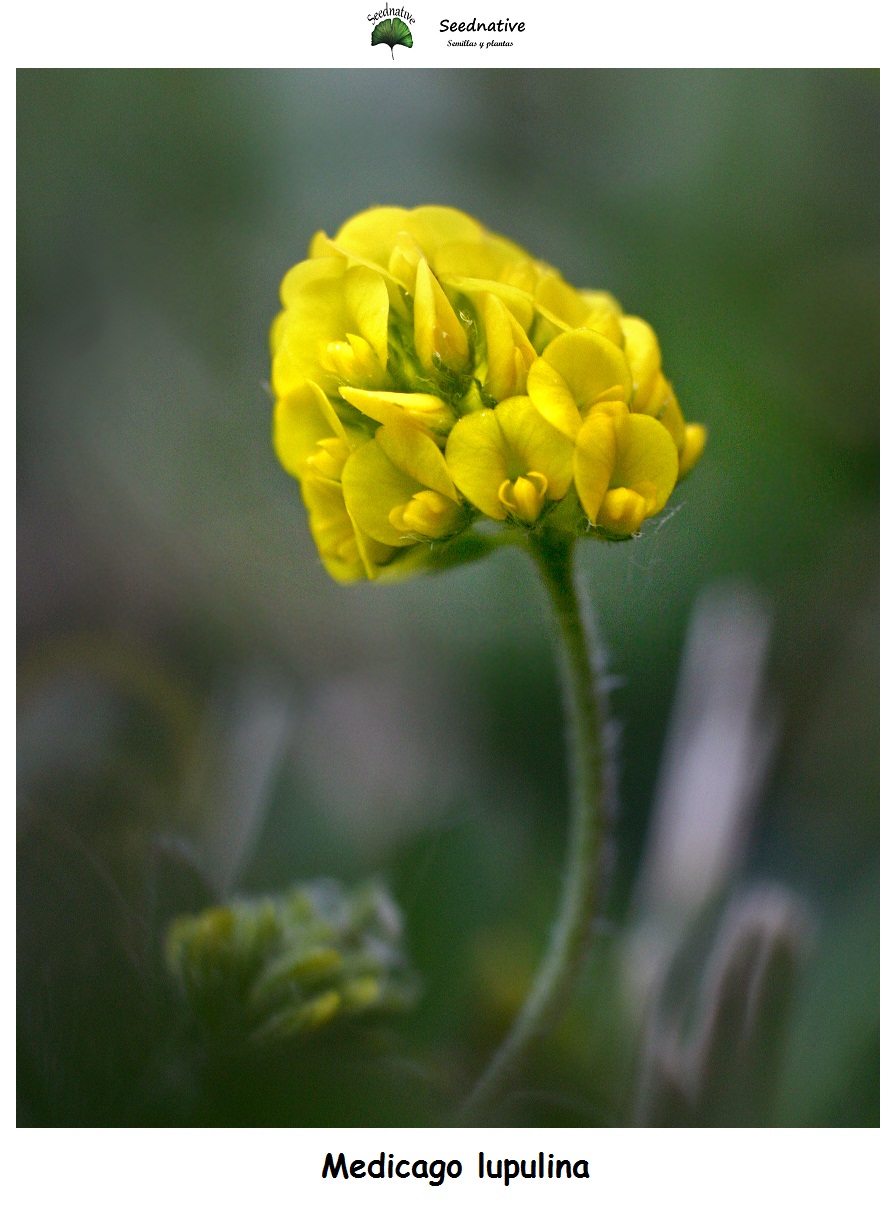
[462,534,610,1120]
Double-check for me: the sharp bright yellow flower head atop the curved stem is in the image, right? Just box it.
[271,205,706,582]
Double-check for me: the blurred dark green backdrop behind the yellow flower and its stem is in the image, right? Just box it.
[17,69,879,1125]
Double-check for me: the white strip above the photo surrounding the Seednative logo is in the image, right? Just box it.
[12,0,881,70]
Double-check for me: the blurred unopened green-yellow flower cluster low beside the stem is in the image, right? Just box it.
[167,881,415,1041]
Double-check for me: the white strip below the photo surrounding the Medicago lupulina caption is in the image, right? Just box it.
[12,1128,888,1208]
